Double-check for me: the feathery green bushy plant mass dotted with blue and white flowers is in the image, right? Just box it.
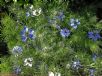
[1,0,102,76]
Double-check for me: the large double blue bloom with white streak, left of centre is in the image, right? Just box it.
[21,26,36,42]
